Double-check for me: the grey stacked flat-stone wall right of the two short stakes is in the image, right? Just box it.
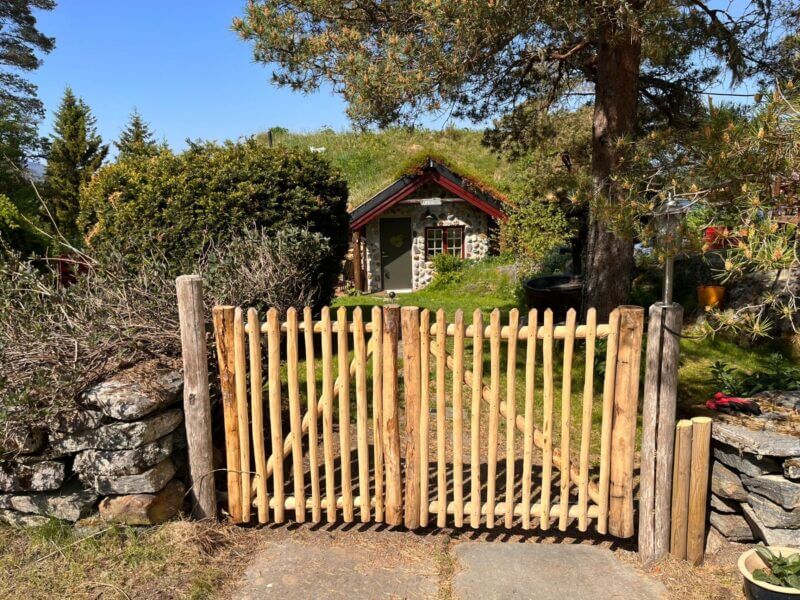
[709,398,800,546]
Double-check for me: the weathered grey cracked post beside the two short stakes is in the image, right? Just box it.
[639,302,683,562]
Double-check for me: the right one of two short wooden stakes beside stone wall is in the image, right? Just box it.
[686,417,711,565]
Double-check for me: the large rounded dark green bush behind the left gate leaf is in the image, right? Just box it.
[79,140,349,302]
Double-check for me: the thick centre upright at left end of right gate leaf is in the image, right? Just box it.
[400,306,421,529]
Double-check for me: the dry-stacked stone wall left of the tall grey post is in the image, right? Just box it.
[0,363,185,525]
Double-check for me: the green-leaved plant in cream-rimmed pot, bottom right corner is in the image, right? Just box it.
[738,546,800,600]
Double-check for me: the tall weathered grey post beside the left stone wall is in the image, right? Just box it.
[175,275,217,519]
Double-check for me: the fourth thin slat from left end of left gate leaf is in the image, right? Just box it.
[286,308,306,523]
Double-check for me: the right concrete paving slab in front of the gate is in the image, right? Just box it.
[453,542,666,600]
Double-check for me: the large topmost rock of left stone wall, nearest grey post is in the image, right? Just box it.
[84,361,183,421]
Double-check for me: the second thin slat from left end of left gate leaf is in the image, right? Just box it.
[247,308,269,524]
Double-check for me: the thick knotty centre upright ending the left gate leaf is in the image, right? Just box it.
[383,304,403,525]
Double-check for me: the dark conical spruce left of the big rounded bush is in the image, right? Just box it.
[45,88,108,241]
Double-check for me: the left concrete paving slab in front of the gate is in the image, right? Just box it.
[232,540,439,600]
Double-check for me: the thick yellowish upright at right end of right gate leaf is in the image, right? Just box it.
[606,306,644,538]
